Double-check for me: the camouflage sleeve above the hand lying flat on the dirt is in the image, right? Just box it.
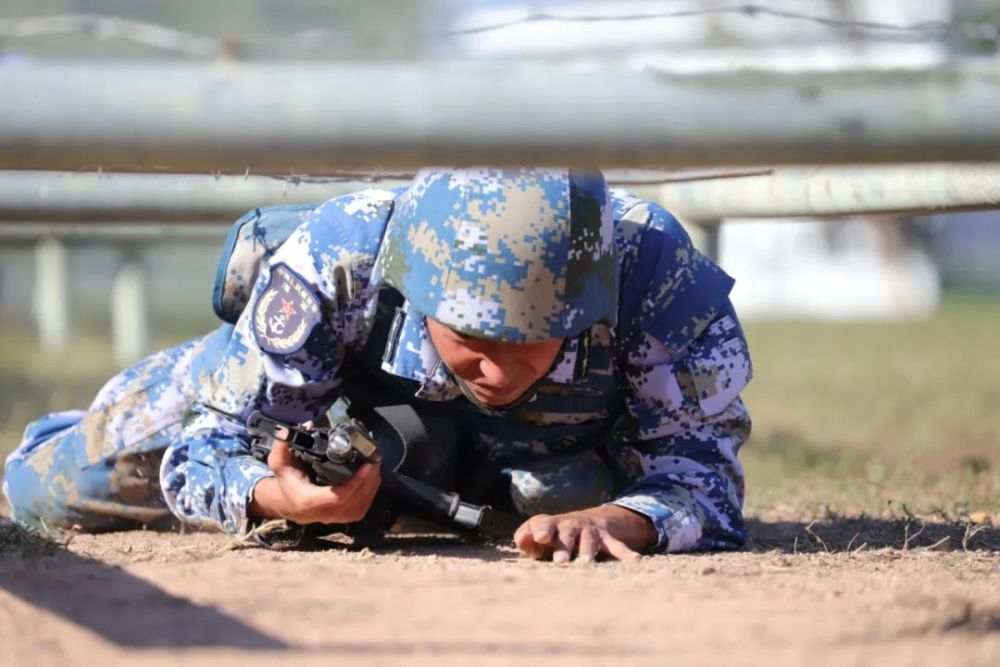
[613,314,752,552]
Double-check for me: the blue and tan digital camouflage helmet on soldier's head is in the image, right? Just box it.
[372,168,618,343]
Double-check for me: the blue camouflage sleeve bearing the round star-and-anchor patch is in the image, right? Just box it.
[160,193,391,533]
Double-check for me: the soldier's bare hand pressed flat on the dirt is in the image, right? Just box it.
[514,505,656,565]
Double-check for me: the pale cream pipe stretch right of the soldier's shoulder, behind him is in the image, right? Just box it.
[657,163,1000,221]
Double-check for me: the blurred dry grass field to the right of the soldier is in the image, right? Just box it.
[744,297,1000,526]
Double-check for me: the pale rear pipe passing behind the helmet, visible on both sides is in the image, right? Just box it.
[0,162,1000,224]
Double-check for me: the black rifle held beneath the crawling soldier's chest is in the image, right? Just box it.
[247,411,520,541]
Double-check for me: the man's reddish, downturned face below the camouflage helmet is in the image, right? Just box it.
[425,317,562,406]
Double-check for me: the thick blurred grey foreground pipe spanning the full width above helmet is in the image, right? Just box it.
[0,62,1000,174]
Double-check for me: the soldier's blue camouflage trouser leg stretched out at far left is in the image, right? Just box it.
[4,326,232,531]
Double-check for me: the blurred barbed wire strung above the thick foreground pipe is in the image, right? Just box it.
[0,3,984,57]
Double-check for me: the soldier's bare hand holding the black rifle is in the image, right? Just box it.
[250,441,381,524]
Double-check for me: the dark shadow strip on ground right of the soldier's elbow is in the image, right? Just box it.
[747,515,1000,553]
